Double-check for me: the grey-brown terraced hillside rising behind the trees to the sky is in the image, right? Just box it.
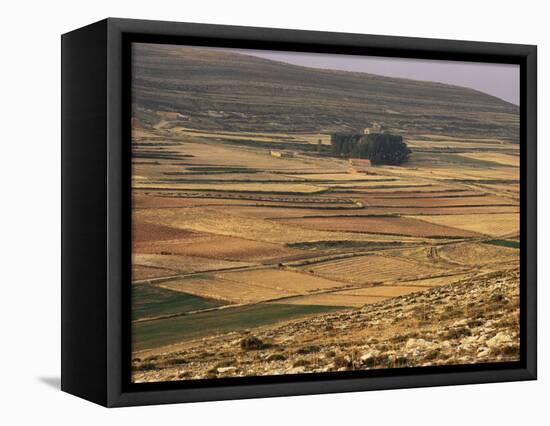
[133,44,519,142]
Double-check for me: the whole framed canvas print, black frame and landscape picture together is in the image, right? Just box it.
[62,19,536,406]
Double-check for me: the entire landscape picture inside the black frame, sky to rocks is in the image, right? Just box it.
[128,43,520,383]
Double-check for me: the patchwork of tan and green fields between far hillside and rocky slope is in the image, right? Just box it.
[133,129,519,366]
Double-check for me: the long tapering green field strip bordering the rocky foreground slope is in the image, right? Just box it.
[132,304,343,351]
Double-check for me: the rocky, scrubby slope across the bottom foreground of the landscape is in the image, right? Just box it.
[133,269,519,382]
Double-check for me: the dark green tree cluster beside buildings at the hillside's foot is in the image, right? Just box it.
[331,133,411,165]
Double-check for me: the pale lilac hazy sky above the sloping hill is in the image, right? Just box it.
[224,49,519,105]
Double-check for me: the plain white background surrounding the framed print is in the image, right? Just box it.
[0,0,550,426]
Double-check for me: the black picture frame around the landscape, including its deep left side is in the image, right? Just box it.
[61,18,537,407]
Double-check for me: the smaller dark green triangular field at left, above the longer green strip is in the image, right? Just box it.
[132,284,225,320]
